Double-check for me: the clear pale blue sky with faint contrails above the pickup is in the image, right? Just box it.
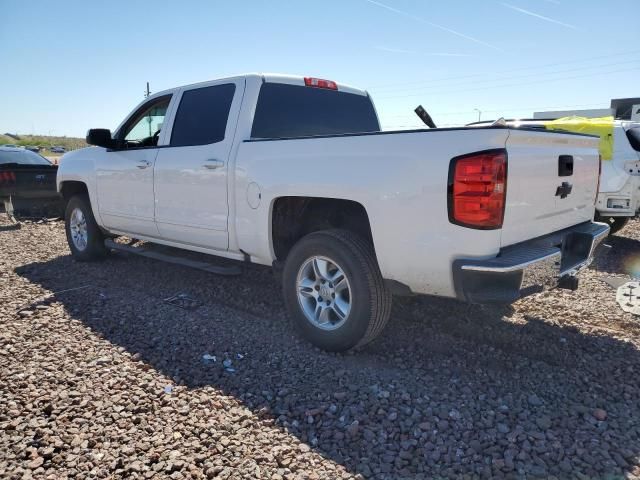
[0,0,640,136]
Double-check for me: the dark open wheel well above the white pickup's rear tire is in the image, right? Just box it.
[271,197,373,261]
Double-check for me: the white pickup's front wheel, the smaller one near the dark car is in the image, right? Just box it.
[64,195,107,262]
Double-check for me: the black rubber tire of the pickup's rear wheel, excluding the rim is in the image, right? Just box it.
[282,230,391,352]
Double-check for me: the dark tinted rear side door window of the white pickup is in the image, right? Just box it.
[171,83,236,147]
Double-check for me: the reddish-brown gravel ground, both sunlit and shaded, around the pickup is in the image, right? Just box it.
[0,216,640,479]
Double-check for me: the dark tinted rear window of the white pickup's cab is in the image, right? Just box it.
[251,83,380,138]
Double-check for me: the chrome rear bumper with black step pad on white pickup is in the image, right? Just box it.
[453,222,609,303]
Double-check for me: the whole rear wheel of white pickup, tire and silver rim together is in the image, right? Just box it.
[283,230,391,351]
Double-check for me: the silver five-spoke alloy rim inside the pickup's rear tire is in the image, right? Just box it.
[296,256,351,330]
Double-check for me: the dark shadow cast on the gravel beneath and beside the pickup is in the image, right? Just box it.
[16,256,640,478]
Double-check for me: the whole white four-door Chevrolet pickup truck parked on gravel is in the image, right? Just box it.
[57,74,609,351]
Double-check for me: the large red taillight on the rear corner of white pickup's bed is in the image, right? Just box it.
[448,149,507,230]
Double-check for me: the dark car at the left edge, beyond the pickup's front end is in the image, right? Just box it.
[0,147,63,217]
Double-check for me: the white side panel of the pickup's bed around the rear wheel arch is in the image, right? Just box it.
[235,128,508,296]
